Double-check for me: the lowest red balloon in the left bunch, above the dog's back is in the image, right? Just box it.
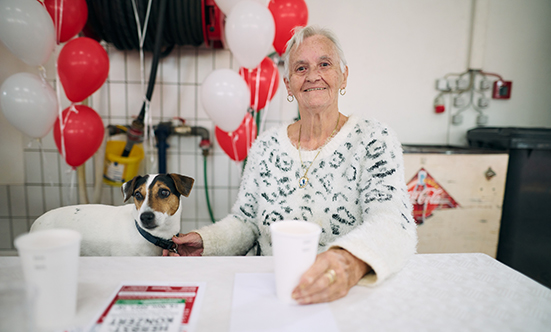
[54,105,105,167]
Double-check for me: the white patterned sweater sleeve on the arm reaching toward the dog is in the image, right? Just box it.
[194,134,262,256]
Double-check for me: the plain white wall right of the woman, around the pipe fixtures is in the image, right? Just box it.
[307,0,551,145]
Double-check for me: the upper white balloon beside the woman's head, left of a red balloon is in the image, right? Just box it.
[226,0,275,69]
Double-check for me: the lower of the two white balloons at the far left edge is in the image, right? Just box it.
[0,73,58,138]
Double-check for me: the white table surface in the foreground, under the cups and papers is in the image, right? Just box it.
[0,254,551,332]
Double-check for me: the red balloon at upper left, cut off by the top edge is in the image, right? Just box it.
[44,0,88,44]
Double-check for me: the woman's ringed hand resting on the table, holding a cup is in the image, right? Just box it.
[292,248,371,304]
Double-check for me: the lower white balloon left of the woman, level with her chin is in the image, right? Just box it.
[201,69,251,132]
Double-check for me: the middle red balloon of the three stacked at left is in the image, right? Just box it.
[57,37,109,103]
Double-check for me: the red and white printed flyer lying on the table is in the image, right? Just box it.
[90,283,205,332]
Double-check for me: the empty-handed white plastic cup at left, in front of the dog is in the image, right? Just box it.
[15,229,82,331]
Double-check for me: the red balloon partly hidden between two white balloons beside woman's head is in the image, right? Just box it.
[239,57,279,112]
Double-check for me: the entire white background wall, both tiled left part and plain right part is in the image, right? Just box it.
[0,0,551,253]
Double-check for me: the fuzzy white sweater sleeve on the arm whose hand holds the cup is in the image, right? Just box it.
[330,123,417,285]
